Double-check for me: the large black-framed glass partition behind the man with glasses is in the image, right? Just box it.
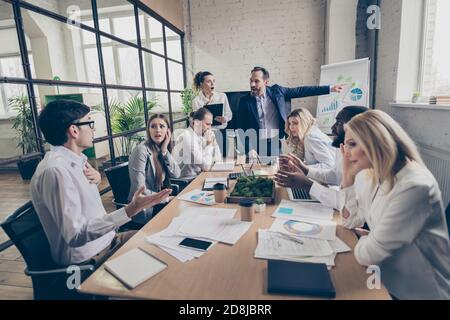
[0,0,185,166]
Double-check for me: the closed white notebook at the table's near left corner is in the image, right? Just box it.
[104,248,167,289]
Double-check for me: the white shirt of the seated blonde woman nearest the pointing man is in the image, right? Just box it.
[305,126,336,169]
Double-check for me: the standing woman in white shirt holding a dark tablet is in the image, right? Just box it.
[192,71,233,129]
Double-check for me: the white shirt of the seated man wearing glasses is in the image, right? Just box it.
[31,146,130,266]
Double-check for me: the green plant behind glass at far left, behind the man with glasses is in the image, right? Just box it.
[8,94,36,155]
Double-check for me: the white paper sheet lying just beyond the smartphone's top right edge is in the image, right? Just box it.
[178,215,252,244]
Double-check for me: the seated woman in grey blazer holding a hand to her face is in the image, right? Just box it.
[128,114,180,225]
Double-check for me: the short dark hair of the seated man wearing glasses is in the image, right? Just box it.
[38,100,91,146]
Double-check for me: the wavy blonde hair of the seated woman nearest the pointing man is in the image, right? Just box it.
[284,108,316,159]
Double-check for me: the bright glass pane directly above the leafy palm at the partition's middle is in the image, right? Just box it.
[101,37,142,87]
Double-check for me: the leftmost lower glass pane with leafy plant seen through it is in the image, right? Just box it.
[0,83,37,158]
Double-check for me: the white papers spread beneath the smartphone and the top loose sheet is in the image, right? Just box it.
[145,207,243,262]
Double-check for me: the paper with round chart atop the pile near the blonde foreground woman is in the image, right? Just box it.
[269,218,336,240]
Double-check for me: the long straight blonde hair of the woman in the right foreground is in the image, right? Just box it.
[346,110,425,192]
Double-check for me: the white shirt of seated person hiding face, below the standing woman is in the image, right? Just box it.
[172,127,222,178]
